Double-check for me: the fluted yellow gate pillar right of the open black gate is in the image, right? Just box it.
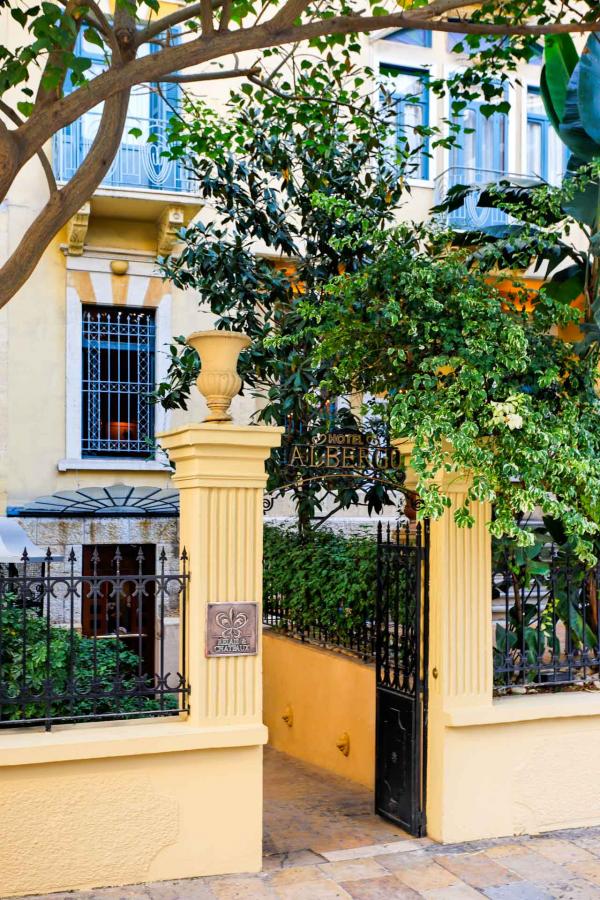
[399,442,494,843]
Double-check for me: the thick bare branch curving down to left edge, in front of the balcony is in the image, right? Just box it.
[0,91,129,309]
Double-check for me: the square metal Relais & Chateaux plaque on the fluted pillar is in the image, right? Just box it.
[206,603,258,656]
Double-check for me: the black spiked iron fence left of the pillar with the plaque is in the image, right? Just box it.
[0,547,189,730]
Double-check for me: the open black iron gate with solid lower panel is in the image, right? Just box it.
[375,522,429,836]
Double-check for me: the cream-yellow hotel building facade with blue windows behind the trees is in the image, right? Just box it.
[0,14,562,547]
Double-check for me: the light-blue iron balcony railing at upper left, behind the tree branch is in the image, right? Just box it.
[52,110,196,193]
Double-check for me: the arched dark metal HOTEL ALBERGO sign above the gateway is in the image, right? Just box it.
[283,432,403,475]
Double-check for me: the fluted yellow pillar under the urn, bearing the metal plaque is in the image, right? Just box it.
[161,422,282,727]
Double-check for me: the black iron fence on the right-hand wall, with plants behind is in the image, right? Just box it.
[493,541,600,692]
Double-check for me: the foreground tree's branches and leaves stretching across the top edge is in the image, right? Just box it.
[0,0,600,306]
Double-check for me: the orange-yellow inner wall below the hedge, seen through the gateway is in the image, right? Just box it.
[263,629,375,788]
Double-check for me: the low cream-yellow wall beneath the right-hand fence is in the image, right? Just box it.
[428,692,600,843]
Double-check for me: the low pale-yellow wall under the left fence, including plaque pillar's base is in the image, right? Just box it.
[0,722,262,897]
